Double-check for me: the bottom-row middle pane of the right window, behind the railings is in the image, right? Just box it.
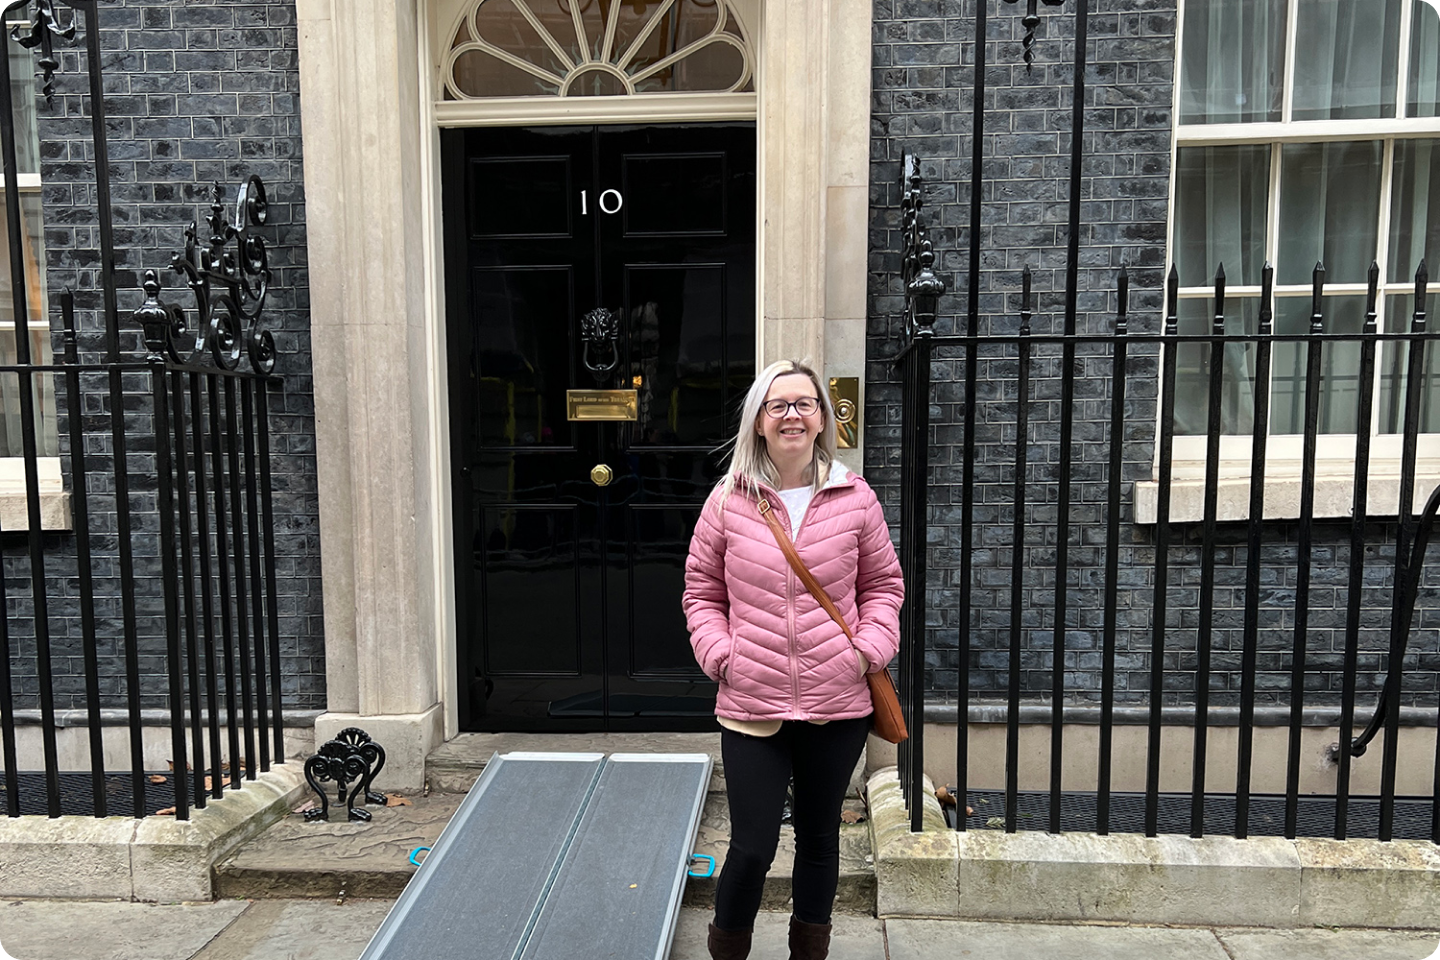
[1270,296,1365,435]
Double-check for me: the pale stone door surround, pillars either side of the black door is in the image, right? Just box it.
[295,0,873,748]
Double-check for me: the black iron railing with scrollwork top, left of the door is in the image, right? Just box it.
[0,0,285,819]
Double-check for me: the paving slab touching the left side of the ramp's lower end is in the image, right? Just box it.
[194,900,390,960]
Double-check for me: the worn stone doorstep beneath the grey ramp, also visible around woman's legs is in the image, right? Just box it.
[215,792,876,915]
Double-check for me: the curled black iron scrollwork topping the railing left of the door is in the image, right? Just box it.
[134,177,275,376]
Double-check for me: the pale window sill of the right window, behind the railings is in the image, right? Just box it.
[1135,475,1440,525]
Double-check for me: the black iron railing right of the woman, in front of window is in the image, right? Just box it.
[894,0,1440,842]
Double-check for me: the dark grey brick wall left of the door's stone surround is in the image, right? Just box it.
[6,0,325,710]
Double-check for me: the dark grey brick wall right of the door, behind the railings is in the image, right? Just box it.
[865,0,1440,713]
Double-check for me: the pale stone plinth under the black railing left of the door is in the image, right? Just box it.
[0,763,305,902]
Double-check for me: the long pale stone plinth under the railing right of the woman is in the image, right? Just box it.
[868,767,1440,928]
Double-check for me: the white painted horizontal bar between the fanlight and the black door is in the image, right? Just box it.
[433,94,759,127]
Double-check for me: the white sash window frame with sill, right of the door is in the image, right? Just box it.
[1136,0,1440,522]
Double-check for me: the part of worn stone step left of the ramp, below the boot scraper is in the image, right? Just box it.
[215,793,465,900]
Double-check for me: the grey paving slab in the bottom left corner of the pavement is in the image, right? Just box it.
[0,900,249,960]
